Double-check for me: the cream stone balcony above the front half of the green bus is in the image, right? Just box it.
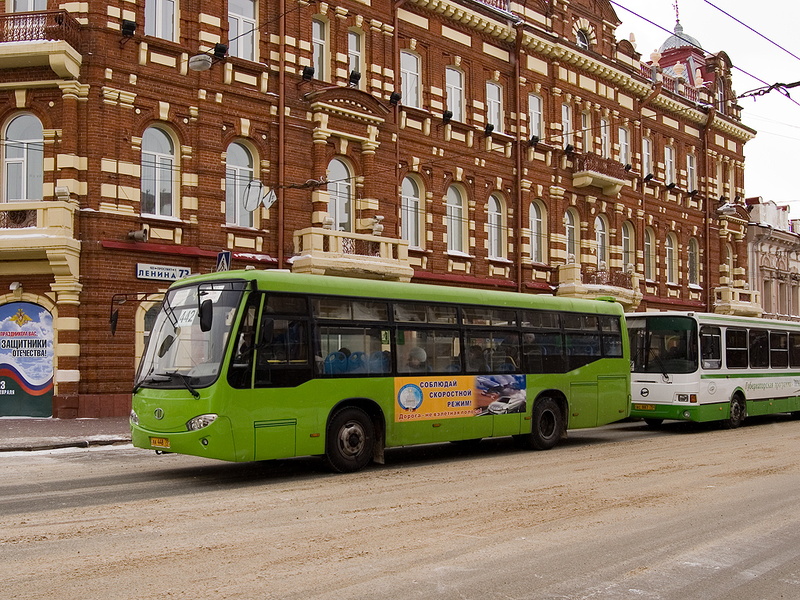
[291,227,414,281]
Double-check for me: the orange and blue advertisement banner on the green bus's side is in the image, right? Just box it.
[395,374,527,423]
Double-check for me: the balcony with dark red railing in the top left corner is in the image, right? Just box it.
[0,10,82,79]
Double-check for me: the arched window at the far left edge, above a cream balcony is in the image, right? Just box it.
[3,113,44,202]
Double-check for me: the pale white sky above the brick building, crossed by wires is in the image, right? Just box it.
[611,0,800,214]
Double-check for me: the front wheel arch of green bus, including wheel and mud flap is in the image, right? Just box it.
[325,398,386,473]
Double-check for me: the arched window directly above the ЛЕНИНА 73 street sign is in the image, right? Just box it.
[141,127,177,217]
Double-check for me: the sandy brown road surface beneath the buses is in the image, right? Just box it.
[0,418,800,600]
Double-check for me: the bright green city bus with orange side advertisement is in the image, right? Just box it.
[131,269,630,472]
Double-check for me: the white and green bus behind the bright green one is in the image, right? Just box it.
[627,312,800,428]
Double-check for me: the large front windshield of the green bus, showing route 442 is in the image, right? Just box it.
[134,281,246,396]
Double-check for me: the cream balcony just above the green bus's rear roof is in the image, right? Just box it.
[556,263,642,311]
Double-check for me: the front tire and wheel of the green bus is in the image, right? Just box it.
[325,406,375,473]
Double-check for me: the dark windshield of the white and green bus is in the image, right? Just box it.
[628,316,697,374]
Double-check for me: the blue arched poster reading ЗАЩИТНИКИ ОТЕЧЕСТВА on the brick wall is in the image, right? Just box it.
[0,302,53,417]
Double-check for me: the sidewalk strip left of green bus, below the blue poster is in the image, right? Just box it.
[0,417,131,453]
